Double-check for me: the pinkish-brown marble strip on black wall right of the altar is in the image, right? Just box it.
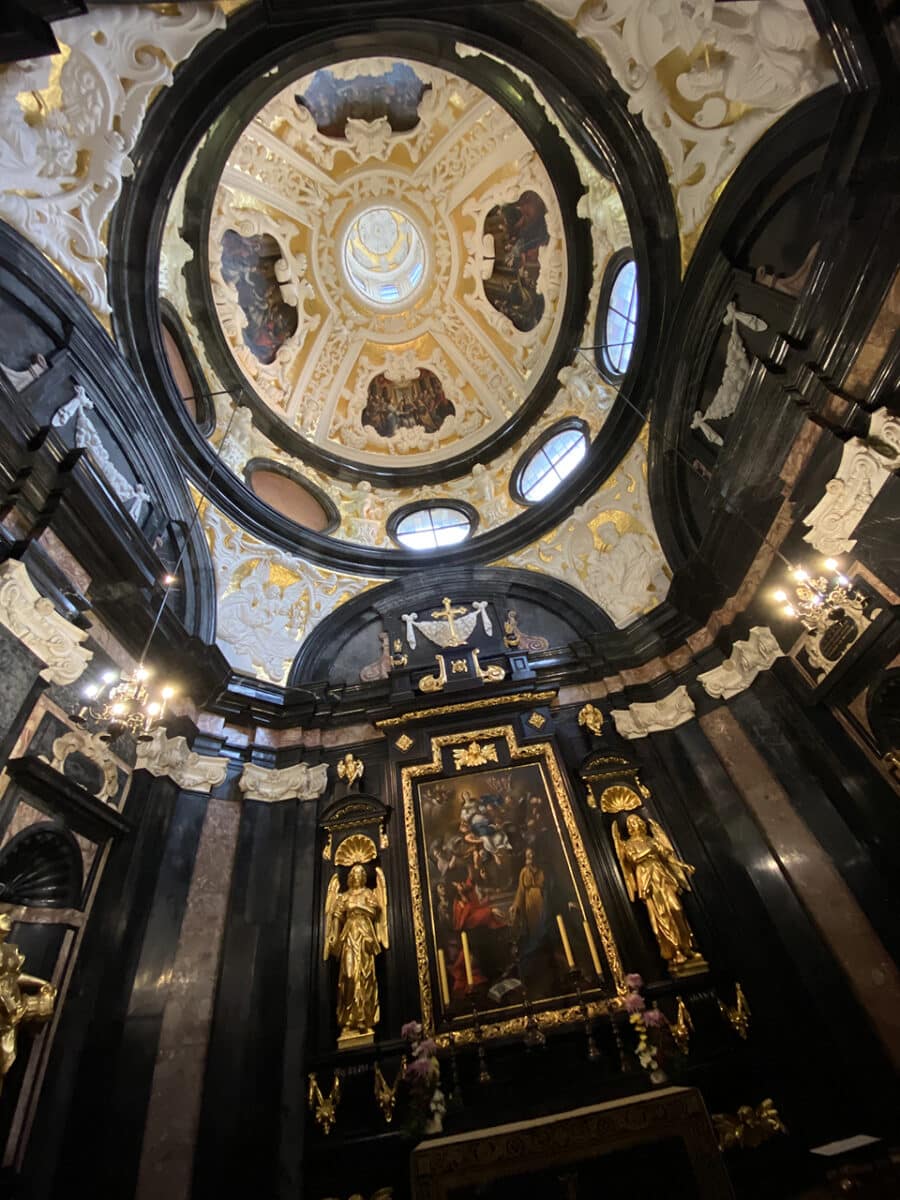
[700,707,900,1067]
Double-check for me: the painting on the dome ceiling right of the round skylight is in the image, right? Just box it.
[484,191,550,332]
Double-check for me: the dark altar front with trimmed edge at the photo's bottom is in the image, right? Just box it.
[412,1087,733,1200]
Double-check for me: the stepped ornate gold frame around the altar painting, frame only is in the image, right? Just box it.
[401,725,626,1046]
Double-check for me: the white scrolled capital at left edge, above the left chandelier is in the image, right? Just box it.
[0,558,94,684]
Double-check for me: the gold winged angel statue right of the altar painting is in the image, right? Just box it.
[612,812,707,976]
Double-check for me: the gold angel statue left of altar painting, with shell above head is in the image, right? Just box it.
[324,834,388,1049]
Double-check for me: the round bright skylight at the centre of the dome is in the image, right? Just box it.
[343,206,426,308]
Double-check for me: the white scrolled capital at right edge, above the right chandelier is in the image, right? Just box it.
[803,408,900,558]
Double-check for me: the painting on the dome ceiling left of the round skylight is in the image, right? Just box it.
[222,229,298,364]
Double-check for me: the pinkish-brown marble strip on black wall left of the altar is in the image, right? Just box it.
[136,799,241,1200]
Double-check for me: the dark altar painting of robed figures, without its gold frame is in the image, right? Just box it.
[413,746,618,1036]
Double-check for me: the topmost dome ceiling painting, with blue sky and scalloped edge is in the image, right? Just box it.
[296,62,431,138]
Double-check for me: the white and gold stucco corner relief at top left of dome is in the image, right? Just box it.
[0,5,226,313]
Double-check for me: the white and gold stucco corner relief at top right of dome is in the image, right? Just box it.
[541,0,833,234]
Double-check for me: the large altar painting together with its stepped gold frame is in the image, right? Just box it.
[401,725,625,1045]
